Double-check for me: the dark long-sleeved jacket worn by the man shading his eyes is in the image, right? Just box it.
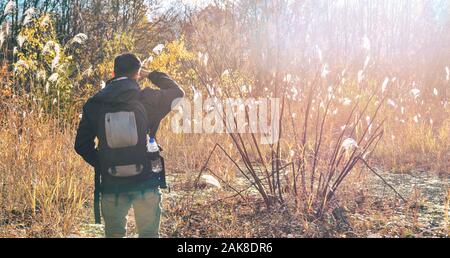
[75,71,184,190]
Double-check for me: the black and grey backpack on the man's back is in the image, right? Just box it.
[97,100,155,193]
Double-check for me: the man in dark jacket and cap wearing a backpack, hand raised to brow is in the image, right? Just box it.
[75,53,184,237]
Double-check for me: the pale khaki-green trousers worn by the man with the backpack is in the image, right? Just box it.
[101,188,161,238]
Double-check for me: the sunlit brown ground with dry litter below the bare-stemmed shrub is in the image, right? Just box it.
[64,171,450,238]
